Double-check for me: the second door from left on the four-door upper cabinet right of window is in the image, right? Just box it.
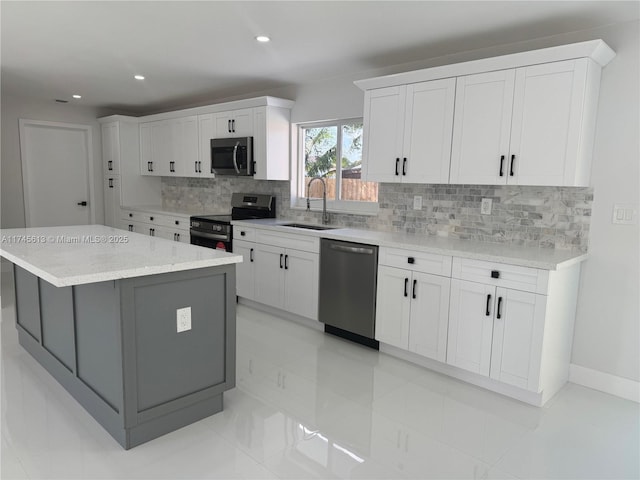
[402,78,456,183]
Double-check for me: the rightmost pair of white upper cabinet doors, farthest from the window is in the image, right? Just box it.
[451,58,596,186]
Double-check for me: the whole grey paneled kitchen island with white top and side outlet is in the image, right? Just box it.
[0,225,242,449]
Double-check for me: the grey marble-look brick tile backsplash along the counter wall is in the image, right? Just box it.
[162,177,593,252]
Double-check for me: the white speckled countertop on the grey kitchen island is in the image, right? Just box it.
[0,225,242,287]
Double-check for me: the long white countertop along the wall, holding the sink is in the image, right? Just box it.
[232,218,588,270]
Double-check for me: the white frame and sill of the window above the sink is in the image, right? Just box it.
[291,117,379,215]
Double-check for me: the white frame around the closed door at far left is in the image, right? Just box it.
[19,118,96,227]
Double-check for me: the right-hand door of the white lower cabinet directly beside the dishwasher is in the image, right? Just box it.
[409,272,451,362]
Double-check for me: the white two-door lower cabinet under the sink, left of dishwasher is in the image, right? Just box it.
[233,230,320,320]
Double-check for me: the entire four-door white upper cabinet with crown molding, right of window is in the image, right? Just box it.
[355,40,615,186]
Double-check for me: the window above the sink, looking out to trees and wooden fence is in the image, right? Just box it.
[297,119,378,213]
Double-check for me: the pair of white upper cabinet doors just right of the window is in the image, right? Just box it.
[363,79,455,183]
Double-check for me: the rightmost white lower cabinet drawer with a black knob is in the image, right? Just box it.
[451,257,549,295]
